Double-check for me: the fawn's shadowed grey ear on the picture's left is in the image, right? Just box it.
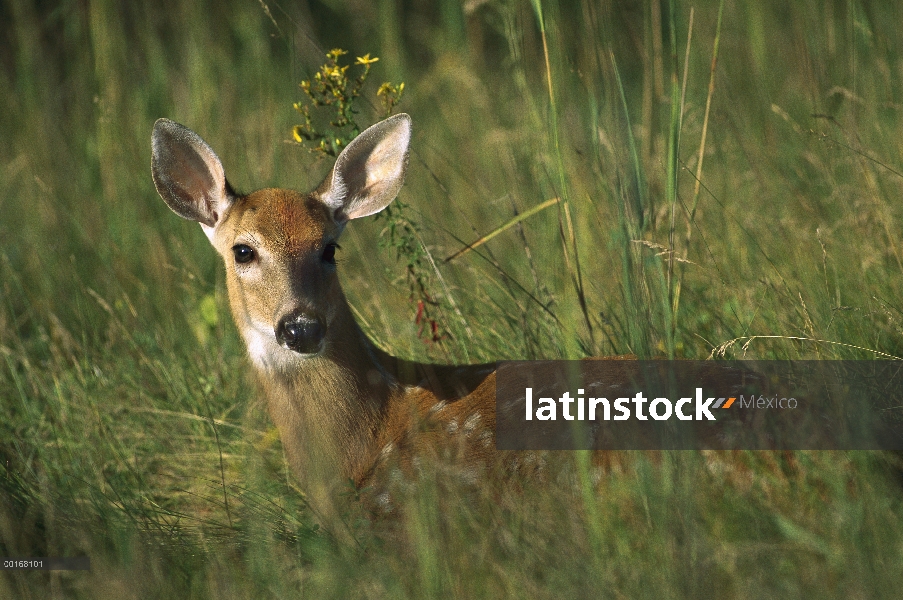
[151,119,232,227]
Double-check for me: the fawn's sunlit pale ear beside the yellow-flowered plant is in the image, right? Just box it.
[317,113,411,223]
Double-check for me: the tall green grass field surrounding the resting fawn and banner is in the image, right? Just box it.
[0,0,903,598]
